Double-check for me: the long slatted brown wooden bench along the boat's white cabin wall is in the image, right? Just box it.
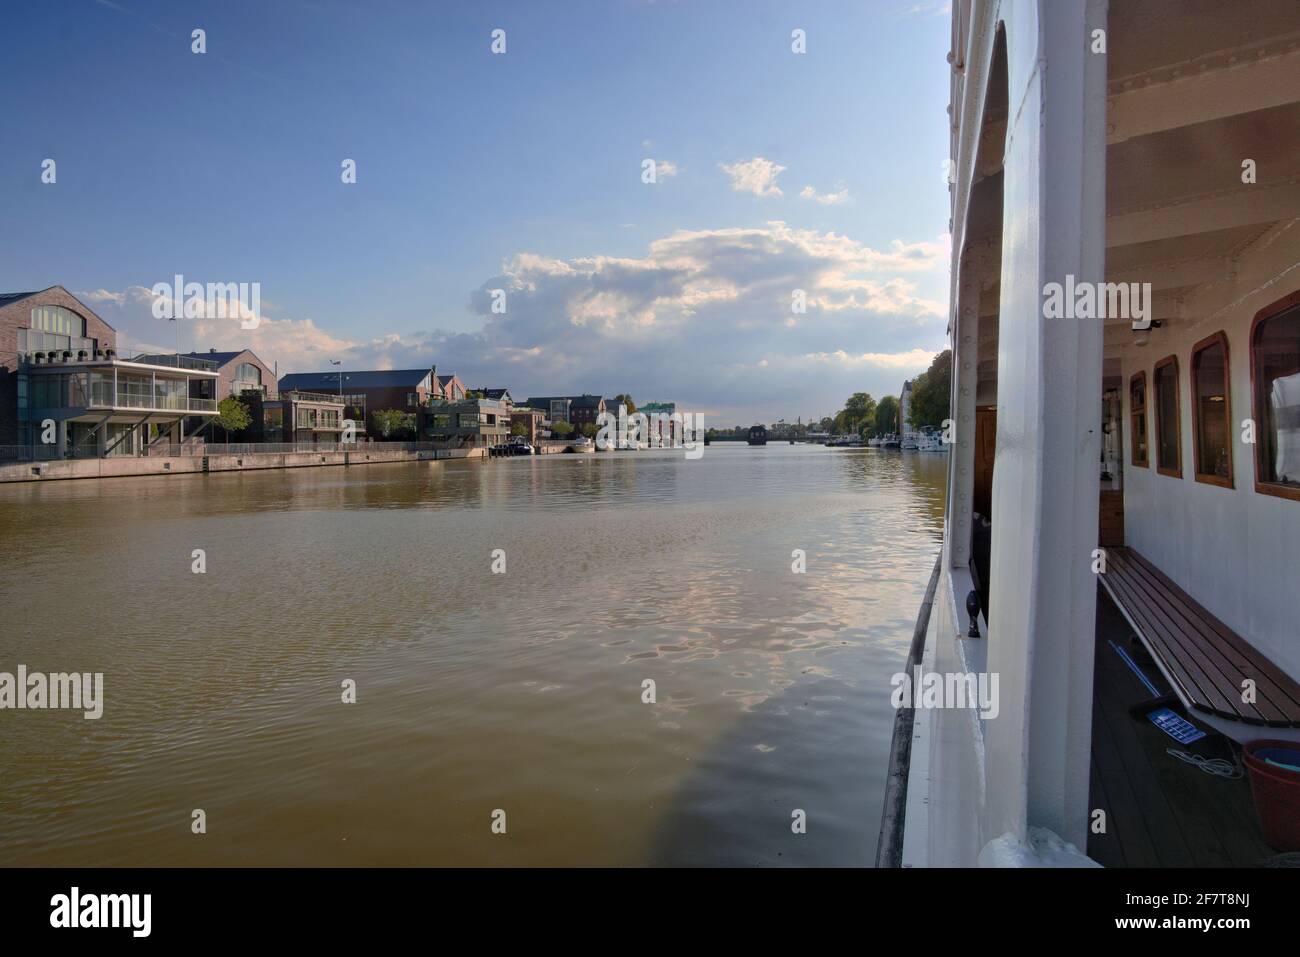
[1100,546,1300,741]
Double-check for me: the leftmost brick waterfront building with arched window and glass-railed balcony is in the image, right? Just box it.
[0,286,220,458]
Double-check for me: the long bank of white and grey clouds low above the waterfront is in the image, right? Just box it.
[89,221,948,425]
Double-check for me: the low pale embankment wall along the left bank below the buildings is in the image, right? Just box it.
[0,447,485,484]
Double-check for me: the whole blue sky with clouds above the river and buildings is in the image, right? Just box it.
[0,0,949,424]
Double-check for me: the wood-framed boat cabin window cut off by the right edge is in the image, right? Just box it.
[1251,293,1300,499]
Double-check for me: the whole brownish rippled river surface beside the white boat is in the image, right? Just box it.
[0,445,946,865]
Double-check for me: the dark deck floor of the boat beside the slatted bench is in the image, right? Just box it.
[1088,588,1278,867]
